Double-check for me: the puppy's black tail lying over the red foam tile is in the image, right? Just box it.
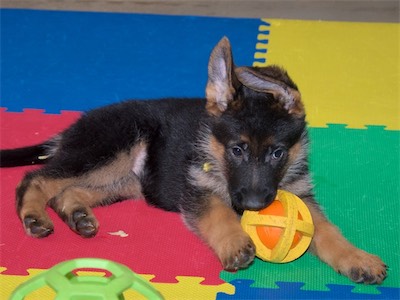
[0,142,50,168]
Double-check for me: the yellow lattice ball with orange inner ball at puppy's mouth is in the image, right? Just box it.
[241,190,314,263]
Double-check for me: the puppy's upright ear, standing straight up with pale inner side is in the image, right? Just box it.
[206,37,240,116]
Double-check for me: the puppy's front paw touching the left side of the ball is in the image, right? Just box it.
[219,233,256,271]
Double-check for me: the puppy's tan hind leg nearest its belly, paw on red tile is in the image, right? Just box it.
[50,142,147,237]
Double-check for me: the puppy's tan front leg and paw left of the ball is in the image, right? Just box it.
[183,196,255,270]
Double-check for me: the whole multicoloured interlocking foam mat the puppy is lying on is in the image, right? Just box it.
[0,9,400,299]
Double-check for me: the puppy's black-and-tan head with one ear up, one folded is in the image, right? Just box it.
[206,38,305,212]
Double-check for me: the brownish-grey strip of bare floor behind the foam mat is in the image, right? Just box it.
[0,0,400,22]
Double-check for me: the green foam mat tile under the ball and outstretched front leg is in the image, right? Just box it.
[221,125,400,294]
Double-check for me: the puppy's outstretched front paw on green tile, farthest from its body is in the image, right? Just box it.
[337,249,387,284]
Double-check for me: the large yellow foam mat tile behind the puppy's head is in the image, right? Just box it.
[254,19,400,130]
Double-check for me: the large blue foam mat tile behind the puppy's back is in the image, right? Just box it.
[0,9,261,113]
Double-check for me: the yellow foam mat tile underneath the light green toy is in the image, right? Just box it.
[0,267,235,300]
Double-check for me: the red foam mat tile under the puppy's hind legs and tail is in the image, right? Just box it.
[0,109,223,284]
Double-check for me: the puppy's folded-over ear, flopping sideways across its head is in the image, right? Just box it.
[236,66,305,117]
